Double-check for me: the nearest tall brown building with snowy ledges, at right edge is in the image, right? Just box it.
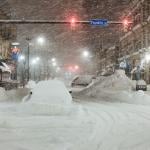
[119,0,150,83]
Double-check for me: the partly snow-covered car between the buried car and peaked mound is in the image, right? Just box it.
[71,75,96,87]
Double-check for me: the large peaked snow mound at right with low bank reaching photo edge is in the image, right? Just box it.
[73,70,150,105]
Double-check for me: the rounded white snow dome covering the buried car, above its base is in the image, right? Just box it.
[29,80,72,104]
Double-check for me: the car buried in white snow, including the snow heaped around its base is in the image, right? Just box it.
[19,80,77,115]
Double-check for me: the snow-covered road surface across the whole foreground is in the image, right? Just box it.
[0,101,150,150]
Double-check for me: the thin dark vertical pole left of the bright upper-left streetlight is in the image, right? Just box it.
[26,38,31,81]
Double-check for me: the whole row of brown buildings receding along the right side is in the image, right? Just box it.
[97,0,150,83]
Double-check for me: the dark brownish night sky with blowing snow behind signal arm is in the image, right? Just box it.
[7,0,129,65]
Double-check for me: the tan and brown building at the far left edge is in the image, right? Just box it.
[0,5,17,80]
